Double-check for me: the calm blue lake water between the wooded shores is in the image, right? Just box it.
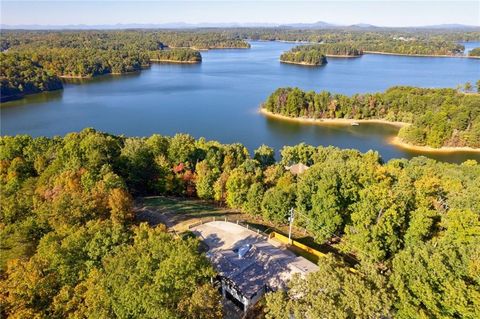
[1,42,480,162]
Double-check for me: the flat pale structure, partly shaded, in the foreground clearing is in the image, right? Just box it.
[192,221,318,311]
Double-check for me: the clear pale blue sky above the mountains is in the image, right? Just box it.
[1,0,480,26]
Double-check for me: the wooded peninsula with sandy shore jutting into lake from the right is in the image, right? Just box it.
[262,87,480,148]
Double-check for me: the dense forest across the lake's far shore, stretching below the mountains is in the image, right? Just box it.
[0,28,480,101]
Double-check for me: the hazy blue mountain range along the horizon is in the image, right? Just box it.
[0,21,480,30]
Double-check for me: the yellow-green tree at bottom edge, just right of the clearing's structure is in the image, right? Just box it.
[266,255,393,319]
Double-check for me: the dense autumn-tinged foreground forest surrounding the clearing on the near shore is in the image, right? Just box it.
[0,129,480,318]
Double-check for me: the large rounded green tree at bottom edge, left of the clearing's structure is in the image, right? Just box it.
[79,224,221,318]
